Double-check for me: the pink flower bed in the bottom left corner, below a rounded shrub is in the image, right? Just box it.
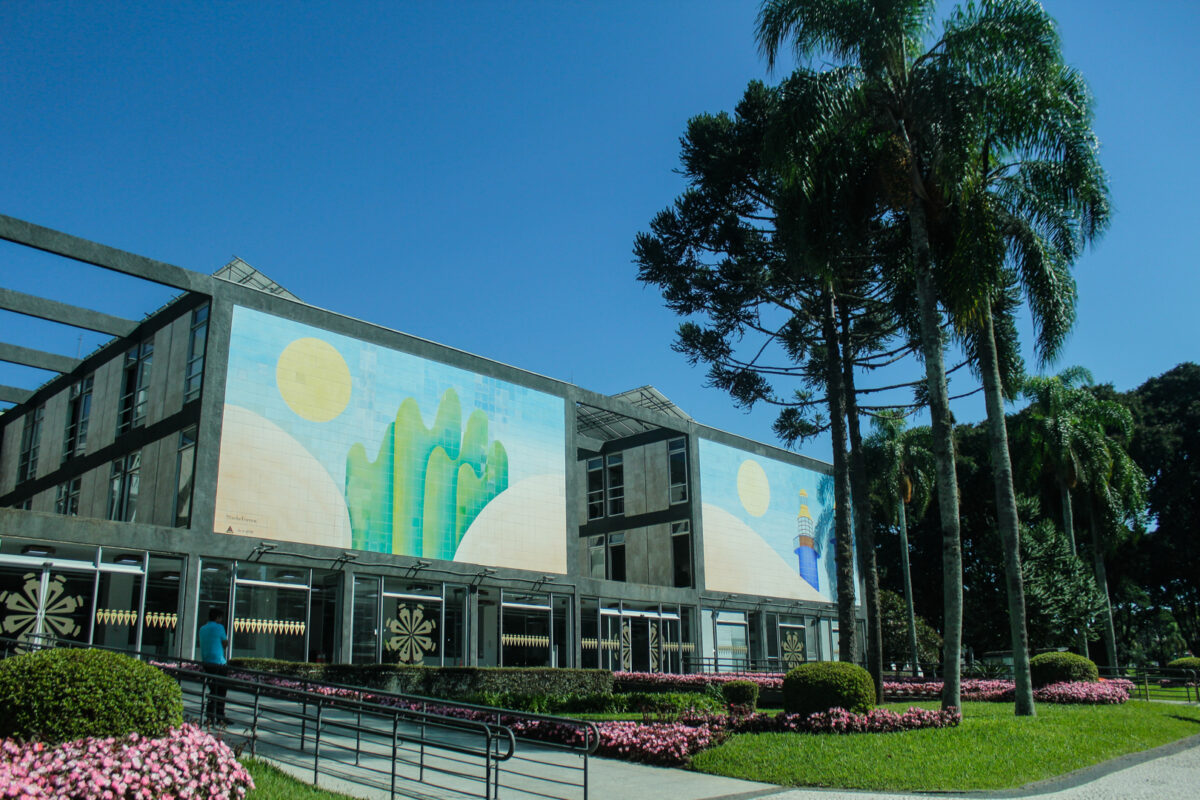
[0,724,254,800]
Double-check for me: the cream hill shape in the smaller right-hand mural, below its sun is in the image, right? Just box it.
[703,503,829,602]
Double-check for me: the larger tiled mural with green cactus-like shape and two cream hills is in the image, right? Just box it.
[215,307,566,572]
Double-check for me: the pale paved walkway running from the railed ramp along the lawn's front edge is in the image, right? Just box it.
[189,692,1200,800]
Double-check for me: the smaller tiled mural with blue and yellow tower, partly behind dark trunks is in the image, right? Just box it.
[700,439,836,602]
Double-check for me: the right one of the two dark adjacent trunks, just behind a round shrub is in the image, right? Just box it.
[841,303,883,703]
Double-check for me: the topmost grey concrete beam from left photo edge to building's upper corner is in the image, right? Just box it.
[0,215,214,295]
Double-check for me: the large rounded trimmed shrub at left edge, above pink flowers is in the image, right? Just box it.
[0,649,184,745]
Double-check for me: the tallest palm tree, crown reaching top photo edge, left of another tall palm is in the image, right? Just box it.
[757,0,1080,708]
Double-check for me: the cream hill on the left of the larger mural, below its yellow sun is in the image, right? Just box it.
[212,403,350,548]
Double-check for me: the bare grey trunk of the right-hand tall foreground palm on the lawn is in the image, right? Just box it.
[977,307,1036,716]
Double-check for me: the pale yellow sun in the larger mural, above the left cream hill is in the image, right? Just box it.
[275,337,350,422]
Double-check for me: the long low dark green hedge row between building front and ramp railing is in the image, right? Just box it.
[232,658,612,699]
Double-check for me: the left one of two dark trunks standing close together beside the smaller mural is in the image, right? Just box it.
[821,284,858,663]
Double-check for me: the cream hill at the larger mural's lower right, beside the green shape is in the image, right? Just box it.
[454,475,566,573]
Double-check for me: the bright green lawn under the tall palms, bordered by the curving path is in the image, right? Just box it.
[692,702,1200,792]
